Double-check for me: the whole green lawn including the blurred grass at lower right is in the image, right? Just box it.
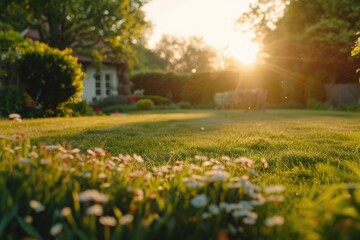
[0,110,360,239]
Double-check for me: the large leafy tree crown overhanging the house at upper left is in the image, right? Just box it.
[0,0,147,63]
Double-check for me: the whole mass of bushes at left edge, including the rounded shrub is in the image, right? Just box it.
[0,31,84,117]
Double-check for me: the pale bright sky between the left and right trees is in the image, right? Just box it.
[145,0,258,63]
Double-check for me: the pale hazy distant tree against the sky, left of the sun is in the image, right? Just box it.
[155,35,217,72]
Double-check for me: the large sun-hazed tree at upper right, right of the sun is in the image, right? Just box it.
[239,0,360,103]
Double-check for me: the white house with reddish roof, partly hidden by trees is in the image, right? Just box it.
[21,29,130,103]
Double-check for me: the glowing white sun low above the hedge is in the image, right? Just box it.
[228,34,260,65]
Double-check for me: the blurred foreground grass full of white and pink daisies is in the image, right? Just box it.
[0,136,285,239]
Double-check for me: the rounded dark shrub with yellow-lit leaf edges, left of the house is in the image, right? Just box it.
[16,42,84,115]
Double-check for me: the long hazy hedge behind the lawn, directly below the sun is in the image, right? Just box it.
[131,68,284,107]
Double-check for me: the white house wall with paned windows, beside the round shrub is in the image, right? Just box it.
[82,65,119,103]
